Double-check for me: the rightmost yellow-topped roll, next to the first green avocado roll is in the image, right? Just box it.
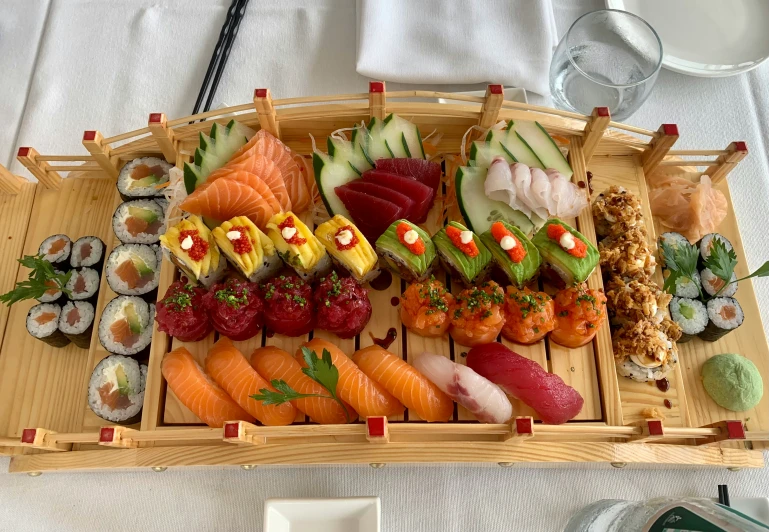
[315,214,379,284]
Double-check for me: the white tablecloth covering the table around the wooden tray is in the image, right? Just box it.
[0,0,769,532]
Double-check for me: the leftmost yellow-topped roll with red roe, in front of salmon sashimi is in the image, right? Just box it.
[160,216,227,288]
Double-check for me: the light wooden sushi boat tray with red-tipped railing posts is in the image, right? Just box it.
[0,82,769,474]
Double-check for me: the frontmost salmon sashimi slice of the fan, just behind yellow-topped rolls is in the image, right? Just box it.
[180,179,275,229]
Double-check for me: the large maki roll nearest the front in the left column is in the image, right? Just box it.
[88,355,147,425]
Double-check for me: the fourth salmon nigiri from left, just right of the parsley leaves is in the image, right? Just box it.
[294,338,404,417]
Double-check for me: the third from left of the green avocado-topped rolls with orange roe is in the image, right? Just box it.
[481,220,542,288]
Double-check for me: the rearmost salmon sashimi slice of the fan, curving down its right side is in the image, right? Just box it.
[227,129,312,213]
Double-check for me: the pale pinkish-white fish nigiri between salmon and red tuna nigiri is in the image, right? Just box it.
[414,353,513,423]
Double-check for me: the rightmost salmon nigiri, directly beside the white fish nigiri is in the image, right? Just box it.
[352,345,454,421]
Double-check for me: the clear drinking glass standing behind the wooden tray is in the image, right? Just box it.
[550,9,662,120]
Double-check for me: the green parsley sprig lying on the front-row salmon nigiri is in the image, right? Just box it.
[251,347,350,423]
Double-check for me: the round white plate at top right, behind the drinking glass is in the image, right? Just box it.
[606,0,769,77]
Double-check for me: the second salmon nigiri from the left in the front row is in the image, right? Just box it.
[206,337,296,425]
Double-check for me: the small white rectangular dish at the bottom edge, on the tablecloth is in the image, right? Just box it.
[264,497,381,532]
